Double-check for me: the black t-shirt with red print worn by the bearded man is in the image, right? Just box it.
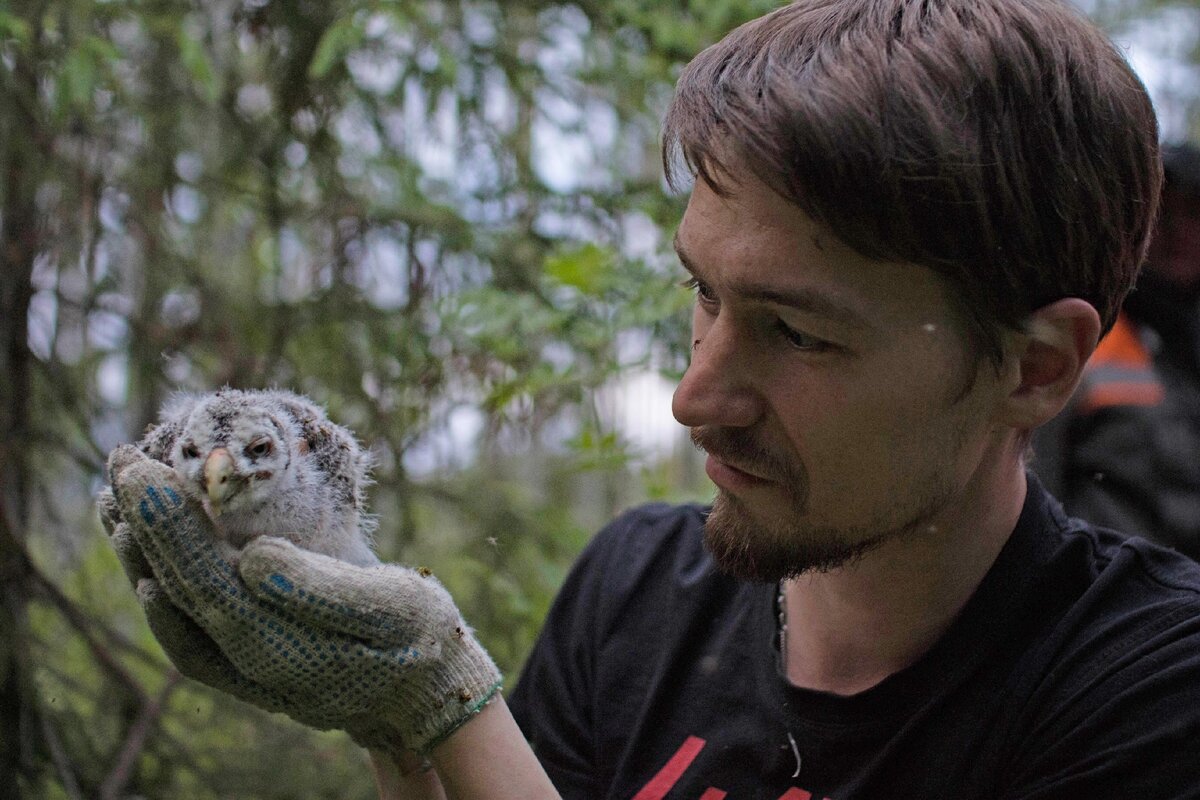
[510,479,1200,800]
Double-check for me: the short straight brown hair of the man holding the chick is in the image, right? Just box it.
[662,0,1162,365]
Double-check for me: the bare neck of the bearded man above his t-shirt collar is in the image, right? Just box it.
[782,462,1026,694]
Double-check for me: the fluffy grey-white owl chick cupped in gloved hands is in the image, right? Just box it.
[138,389,378,566]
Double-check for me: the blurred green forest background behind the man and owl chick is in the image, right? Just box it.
[0,0,1200,800]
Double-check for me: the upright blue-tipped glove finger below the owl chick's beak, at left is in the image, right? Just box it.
[109,449,246,616]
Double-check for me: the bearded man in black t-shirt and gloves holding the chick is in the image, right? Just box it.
[103,0,1200,800]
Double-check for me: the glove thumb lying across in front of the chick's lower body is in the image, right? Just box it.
[238,536,463,649]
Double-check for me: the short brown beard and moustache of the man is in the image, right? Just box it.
[691,427,954,583]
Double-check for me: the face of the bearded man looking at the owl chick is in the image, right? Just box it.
[672,173,1001,581]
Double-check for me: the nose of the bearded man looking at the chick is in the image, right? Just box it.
[671,319,763,428]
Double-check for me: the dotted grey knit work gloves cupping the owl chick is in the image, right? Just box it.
[98,446,500,753]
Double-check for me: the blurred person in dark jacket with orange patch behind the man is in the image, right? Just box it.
[1033,144,1200,559]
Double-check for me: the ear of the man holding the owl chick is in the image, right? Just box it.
[1003,297,1100,429]
